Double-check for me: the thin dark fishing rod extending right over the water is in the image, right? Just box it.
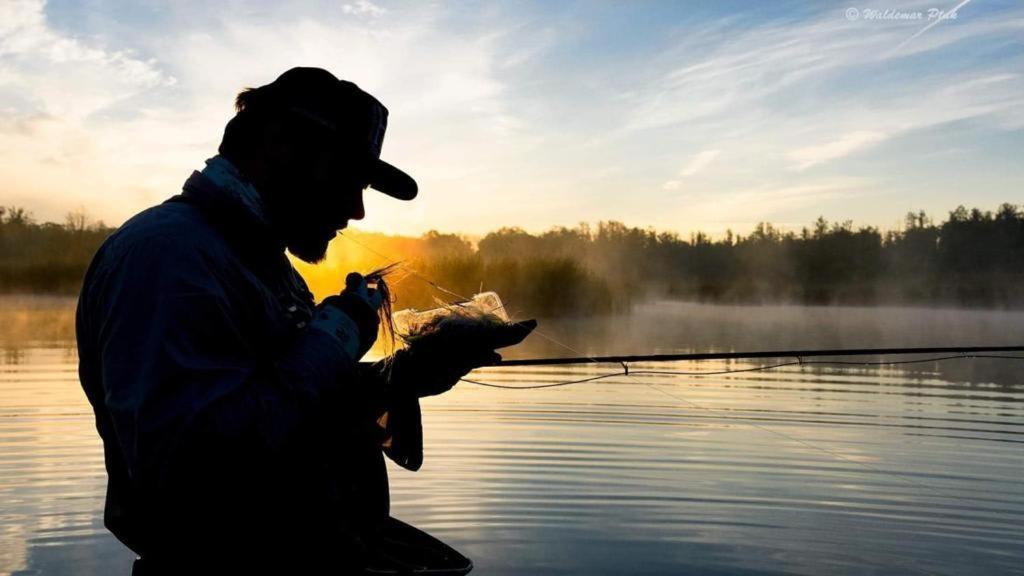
[490,345,1024,367]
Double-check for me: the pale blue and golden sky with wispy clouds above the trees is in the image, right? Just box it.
[0,0,1024,235]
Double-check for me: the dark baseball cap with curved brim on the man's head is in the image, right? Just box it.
[246,67,418,200]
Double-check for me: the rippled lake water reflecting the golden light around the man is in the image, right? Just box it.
[0,298,1024,575]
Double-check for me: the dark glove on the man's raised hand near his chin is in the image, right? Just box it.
[309,272,382,360]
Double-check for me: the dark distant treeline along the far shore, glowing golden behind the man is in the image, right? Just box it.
[0,199,1024,316]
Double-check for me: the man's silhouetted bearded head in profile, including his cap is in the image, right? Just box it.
[219,68,417,263]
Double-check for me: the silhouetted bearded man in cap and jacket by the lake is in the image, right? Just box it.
[77,68,498,574]
